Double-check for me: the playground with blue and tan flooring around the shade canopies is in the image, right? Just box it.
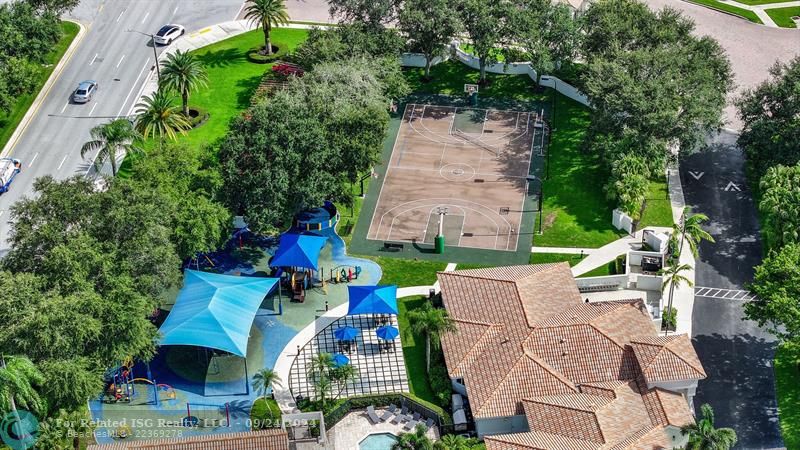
[89,210,381,444]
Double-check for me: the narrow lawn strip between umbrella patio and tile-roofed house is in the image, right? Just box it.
[398,296,439,405]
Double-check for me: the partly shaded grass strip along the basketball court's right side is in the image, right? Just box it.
[533,95,620,248]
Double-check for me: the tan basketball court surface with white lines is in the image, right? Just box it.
[367,103,544,252]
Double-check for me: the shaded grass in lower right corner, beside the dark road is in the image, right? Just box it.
[775,344,800,448]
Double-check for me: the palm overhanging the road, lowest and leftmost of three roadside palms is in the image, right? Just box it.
[81,119,141,176]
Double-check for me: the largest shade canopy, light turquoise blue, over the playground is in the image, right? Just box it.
[158,270,278,357]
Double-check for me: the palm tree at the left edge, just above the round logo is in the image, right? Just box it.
[0,355,44,423]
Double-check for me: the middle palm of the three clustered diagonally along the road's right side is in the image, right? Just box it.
[136,89,192,141]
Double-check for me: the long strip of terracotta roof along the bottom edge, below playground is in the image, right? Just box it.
[88,429,289,450]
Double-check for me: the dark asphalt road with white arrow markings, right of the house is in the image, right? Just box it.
[681,132,783,449]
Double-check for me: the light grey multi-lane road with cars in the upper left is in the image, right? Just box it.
[0,0,243,255]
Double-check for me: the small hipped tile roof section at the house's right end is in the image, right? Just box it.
[631,334,706,384]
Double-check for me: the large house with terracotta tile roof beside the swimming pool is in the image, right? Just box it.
[438,263,706,450]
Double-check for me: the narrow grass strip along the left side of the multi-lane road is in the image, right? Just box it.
[0,21,80,148]
